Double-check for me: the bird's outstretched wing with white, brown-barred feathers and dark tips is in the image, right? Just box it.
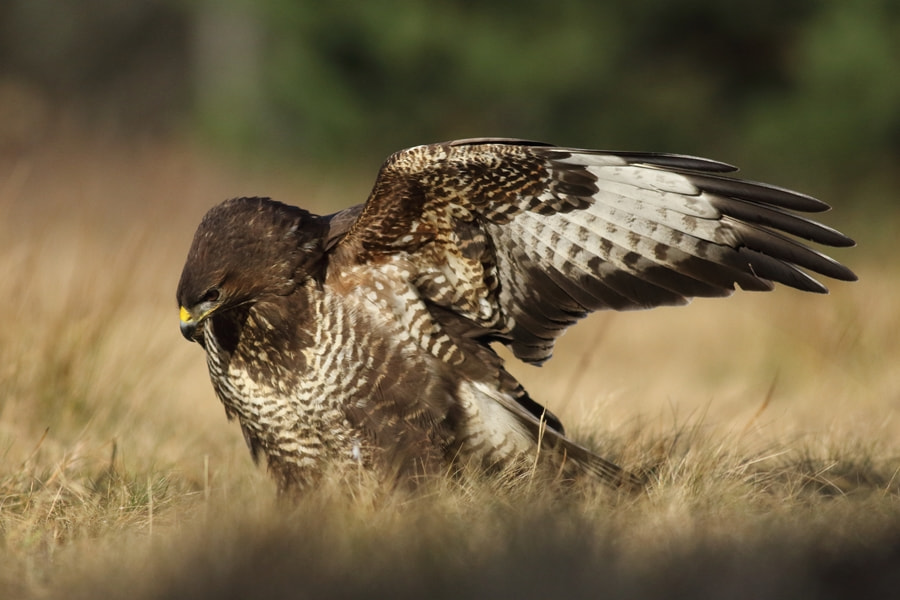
[337,140,856,362]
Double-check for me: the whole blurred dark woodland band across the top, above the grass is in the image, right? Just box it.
[0,0,900,210]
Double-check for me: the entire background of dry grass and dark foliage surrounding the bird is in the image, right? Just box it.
[0,0,900,600]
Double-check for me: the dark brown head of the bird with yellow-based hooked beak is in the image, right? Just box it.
[176,198,323,341]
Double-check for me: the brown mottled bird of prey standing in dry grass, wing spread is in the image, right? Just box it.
[177,139,856,490]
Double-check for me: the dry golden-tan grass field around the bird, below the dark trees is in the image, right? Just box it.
[0,129,900,599]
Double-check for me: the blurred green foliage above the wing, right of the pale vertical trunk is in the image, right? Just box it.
[220,0,900,192]
